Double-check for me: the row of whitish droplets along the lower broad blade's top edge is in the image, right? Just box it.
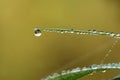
[41,63,120,80]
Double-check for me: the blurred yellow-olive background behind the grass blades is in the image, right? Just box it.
[0,0,120,80]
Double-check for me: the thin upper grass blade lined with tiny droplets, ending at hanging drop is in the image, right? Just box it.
[39,28,120,39]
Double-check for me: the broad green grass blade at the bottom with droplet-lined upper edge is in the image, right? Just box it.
[41,63,120,80]
